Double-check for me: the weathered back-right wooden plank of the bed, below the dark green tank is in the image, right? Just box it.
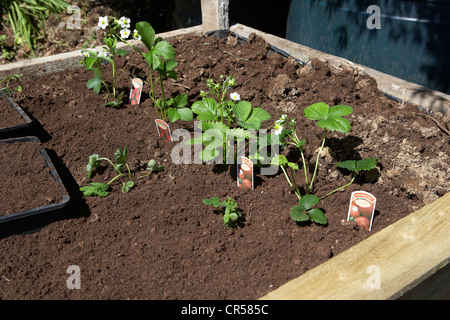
[230,24,450,116]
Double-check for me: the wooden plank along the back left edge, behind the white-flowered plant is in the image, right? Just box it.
[0,26,201,79]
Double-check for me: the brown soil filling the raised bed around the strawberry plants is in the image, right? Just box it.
[0,30,450,299]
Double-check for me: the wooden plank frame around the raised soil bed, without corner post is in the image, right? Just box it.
[0,19,450,300]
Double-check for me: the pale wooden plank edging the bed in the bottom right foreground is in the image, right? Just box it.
[261,193,450,300]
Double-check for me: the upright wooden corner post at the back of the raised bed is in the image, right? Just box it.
[202,0,230,33]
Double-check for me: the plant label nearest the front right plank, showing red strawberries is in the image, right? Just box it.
[347,191,377,231]
